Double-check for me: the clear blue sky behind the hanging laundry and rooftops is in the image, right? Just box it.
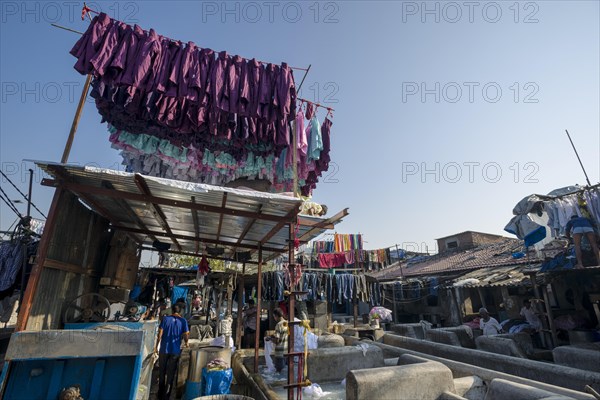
[0,1,600,250]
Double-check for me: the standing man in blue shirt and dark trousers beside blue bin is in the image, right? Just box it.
[154,304,190,400]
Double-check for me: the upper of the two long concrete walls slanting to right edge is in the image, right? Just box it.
[383,334,600,390]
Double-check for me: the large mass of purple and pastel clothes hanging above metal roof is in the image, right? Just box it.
[71,13,332,195]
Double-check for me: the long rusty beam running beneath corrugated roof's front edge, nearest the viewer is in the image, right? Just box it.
[42,179,299,225]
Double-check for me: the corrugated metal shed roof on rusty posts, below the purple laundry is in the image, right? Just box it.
[35,161,347,268]
